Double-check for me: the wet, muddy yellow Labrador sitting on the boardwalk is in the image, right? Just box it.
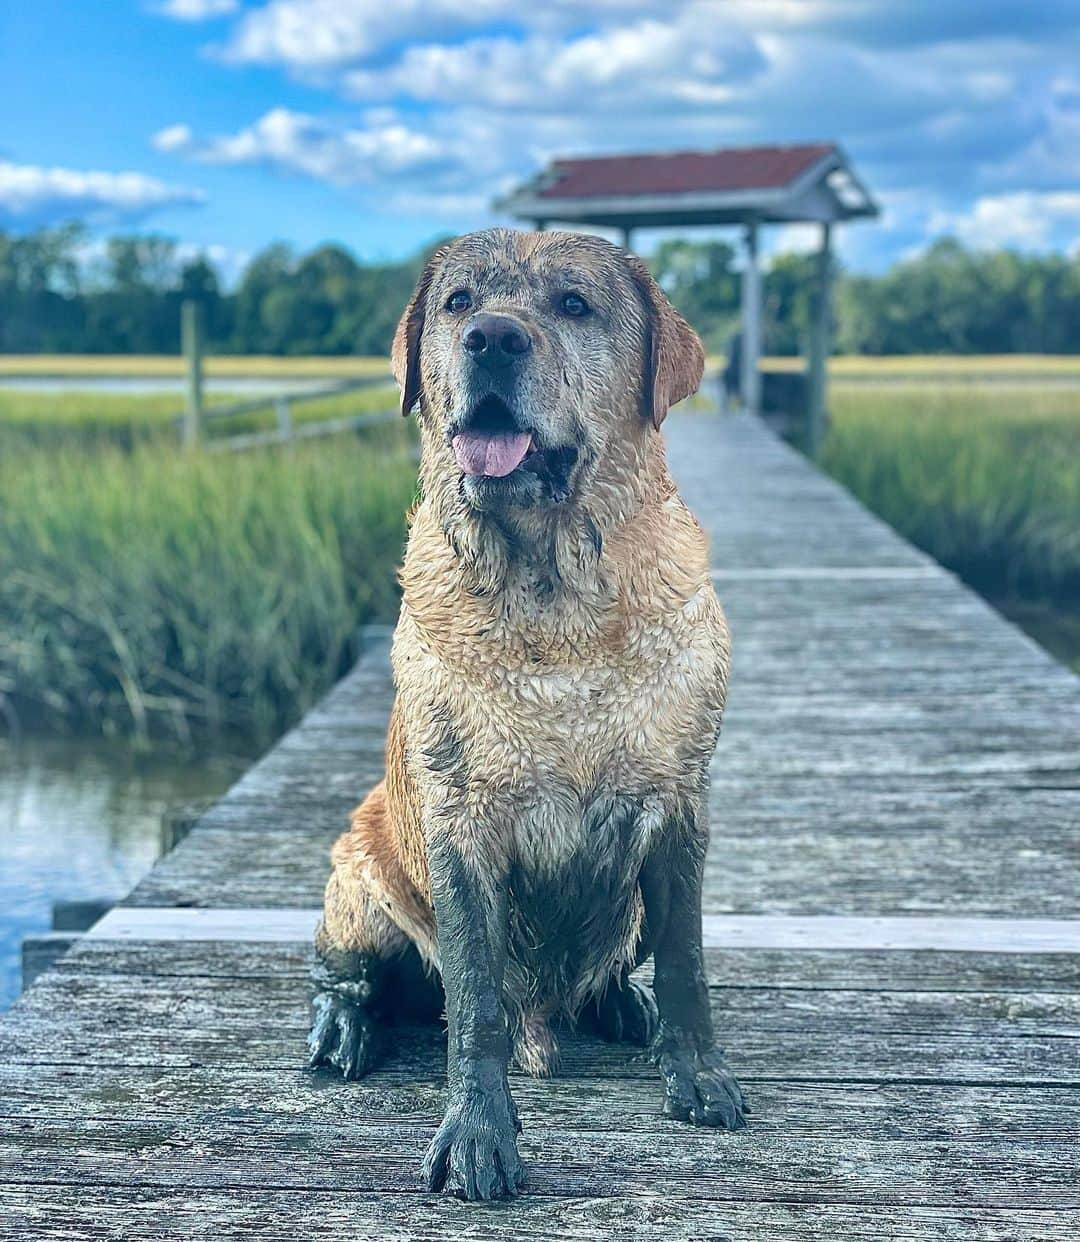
[310,230,746,1199]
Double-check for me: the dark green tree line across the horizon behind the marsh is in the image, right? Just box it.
[0,225,1080,355]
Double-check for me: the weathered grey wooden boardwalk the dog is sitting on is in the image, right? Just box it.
[0,415,1080,1242]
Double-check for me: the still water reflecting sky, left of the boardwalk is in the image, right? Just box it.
[0,739,251,1010]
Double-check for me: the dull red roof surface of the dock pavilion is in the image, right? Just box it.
[535,143,835,199]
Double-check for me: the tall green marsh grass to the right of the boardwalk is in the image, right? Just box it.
[823,384,1080,640]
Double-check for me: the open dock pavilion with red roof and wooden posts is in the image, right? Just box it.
[497,143,879,453]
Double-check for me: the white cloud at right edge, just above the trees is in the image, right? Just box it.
[927,190,1080,250]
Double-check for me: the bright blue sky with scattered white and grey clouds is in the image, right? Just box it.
[0,0,1080,272]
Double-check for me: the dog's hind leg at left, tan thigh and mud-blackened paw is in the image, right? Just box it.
[308,785,443,1079]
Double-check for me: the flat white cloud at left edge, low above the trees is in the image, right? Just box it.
[0,160,205,229]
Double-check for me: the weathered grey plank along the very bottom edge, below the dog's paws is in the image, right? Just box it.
[0,1185,1080,1242]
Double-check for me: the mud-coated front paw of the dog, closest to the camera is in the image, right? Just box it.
[423,1083,525,1200]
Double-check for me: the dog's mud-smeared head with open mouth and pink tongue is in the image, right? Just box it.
[392,229,704,510]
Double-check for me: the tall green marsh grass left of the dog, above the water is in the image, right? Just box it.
[0,425,415,740]
